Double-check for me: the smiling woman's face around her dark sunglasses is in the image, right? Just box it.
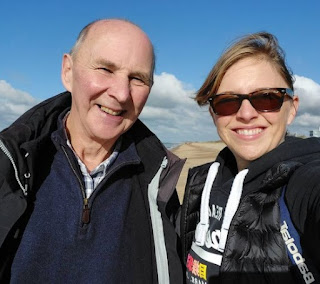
[210,57,298,171]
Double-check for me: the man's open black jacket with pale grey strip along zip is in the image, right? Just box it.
[0,92,184,283]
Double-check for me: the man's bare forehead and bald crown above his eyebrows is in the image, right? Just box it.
[78,20,154,73]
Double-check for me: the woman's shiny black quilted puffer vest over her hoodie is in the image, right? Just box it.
[181,137,320,283]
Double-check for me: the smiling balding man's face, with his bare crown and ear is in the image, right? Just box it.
[62,21,153,147]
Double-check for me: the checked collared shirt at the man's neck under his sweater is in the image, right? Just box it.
[64,113,122,198]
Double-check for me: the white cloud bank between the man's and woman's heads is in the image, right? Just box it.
[140,73,219,142]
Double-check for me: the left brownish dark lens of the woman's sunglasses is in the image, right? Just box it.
[212,95,241,115]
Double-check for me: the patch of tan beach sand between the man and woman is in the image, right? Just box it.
[171,141,225,202]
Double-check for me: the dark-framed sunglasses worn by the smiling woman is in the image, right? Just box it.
[208,88,293,115]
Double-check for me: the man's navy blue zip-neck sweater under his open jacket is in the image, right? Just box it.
[11,129,145,283]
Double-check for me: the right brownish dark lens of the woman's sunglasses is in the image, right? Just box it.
[250,90,283,111]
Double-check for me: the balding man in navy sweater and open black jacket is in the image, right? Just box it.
[0,19,183,283]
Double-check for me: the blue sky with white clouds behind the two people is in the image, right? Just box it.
[0,0,320,143]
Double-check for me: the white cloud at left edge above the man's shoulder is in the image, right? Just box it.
[0,80,37,130]
